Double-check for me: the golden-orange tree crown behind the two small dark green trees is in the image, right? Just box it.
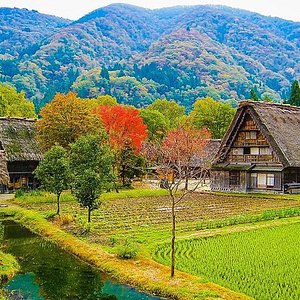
[36,92,103,150]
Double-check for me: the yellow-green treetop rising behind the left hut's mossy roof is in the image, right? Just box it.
[0,84,37,118]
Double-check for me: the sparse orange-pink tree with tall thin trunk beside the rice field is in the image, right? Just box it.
[143,127,211,277]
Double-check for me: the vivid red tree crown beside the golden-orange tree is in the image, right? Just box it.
[94,105,147,152]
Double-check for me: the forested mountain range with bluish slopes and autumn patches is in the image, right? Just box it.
[0,4,300,108]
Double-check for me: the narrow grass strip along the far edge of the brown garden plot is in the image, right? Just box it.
[16,188,168,204]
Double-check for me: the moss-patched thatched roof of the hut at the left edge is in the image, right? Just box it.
[0,118,42,161]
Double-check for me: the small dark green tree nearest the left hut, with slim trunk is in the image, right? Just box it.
[34,146,71,215]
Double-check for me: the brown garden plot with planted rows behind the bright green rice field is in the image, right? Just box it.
[22,193,300,244]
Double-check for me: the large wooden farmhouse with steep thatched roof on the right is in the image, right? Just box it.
[211,101,300,192]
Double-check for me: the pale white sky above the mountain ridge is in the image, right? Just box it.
[0,0,300,21]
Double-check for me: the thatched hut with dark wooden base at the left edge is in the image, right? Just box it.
[0,118,42,189]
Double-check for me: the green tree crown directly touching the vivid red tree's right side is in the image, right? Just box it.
[139,108,168,141]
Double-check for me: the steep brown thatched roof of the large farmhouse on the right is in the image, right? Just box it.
[214,101,300,167]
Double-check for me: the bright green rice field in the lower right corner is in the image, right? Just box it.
[154,222,300,300]
